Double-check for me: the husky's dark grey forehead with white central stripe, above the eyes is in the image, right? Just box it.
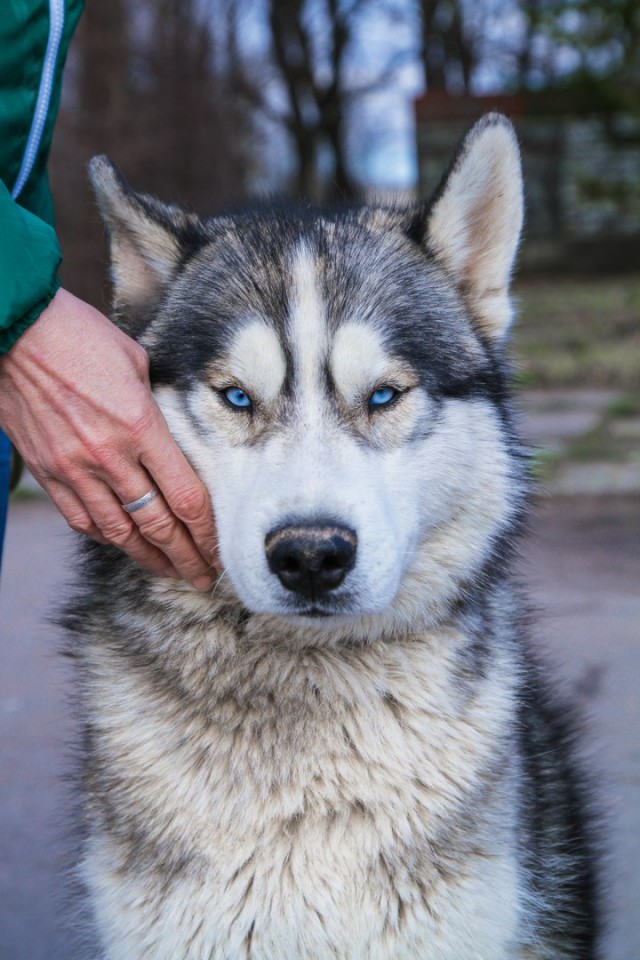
[151,213,478,390]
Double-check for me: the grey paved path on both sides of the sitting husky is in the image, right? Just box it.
[0,497,640,960]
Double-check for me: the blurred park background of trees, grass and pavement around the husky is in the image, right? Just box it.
[0,0,640,960]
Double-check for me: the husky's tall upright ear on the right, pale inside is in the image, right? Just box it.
[424,113,523,339]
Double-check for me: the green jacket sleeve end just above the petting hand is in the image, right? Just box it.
[0,174,62,354]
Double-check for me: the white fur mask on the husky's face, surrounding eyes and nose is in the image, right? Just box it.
[154,248,510,622]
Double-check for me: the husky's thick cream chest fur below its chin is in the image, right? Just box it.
[79,596,517,960]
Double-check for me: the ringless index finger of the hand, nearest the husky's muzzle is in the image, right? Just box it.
[140,410,220,567]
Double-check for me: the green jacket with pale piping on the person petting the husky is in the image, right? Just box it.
[0,0,83,354]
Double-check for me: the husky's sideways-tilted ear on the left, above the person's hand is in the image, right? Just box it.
[89,157,206,337]
